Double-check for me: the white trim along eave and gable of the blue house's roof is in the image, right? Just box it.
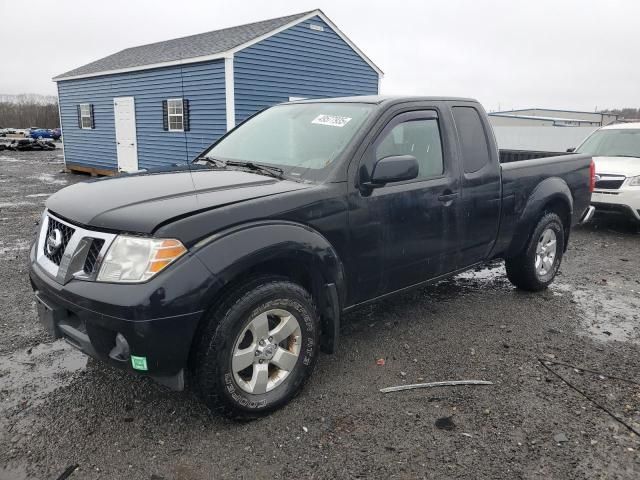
[52,9,384,82]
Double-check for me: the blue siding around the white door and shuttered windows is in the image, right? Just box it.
[58,60,226,169]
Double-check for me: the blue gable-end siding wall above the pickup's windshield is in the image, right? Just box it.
[234,17,378,124]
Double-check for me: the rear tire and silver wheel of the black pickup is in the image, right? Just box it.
[505,212,564,292]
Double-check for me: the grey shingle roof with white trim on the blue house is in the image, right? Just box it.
[53,9,382,81]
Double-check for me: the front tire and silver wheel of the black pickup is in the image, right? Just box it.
[194,277,320,419]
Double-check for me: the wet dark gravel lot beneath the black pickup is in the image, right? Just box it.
[0,151,640,480]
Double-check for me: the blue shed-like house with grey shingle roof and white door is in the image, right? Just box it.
[53,10,382,173]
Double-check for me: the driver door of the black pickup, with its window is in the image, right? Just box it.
[349,109,460,303]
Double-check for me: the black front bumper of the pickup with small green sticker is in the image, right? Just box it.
[29,242,212,390]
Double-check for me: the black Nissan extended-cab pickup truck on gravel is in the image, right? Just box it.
[30,97,594,417]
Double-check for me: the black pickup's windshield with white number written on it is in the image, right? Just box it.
[204,103,374,180]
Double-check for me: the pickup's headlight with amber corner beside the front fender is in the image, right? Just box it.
[98,235,187,283]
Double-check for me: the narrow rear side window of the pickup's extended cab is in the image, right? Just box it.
[452,107,490,173]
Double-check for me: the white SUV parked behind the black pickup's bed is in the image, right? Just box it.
[575,123,640,221]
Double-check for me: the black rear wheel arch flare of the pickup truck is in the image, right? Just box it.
[505,177,573,258]
